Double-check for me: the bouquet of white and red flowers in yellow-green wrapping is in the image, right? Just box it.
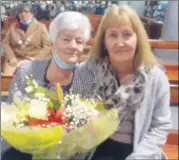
[1,77,119,160]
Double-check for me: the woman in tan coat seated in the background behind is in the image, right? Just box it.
[3,3,51,75]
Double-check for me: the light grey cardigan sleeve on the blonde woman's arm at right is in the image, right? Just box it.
[127,74,171,160]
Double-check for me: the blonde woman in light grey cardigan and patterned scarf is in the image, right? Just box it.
[74,6,171,160]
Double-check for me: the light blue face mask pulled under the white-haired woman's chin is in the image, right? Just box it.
[53,53,78,70]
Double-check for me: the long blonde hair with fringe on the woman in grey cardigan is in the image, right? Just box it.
[89,5,157,70]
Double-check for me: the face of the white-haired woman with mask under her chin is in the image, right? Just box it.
[54,29,84,64]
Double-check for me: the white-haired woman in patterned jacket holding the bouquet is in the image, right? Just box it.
[2,12,91,160]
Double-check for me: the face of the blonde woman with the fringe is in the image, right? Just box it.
[105,23,137,63]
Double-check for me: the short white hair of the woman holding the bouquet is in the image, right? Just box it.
[49,11,91,43]
